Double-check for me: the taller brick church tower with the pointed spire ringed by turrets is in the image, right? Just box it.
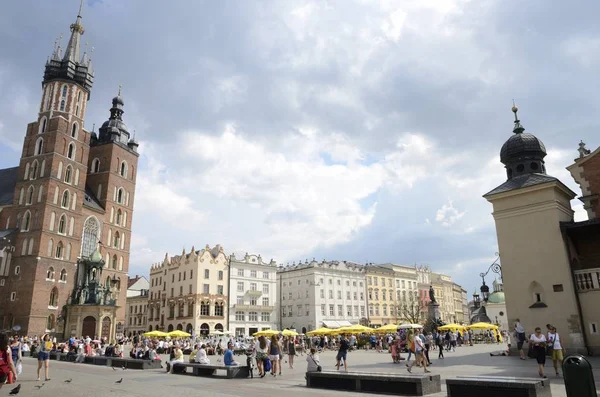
[2,3,94,332]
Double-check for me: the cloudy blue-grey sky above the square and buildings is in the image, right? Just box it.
[0,0,600,294]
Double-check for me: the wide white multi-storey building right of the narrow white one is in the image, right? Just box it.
[277,260,368,333]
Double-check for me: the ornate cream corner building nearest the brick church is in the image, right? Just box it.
[148,245,229,335]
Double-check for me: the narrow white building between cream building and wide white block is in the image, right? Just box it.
[228,254,279,336]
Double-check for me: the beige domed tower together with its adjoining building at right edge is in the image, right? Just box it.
[483,106,600,354]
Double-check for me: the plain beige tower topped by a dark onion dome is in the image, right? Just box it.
[484,106,584,350]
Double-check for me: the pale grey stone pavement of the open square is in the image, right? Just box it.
[0,345,600,397]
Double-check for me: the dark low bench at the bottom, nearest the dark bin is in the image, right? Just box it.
[446,376,552,397]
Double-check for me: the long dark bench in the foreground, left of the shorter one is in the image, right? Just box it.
[306,371,440,397]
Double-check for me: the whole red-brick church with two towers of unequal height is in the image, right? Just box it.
[0,1,138,339]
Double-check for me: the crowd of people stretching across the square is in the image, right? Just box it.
[0,320,565,387]
